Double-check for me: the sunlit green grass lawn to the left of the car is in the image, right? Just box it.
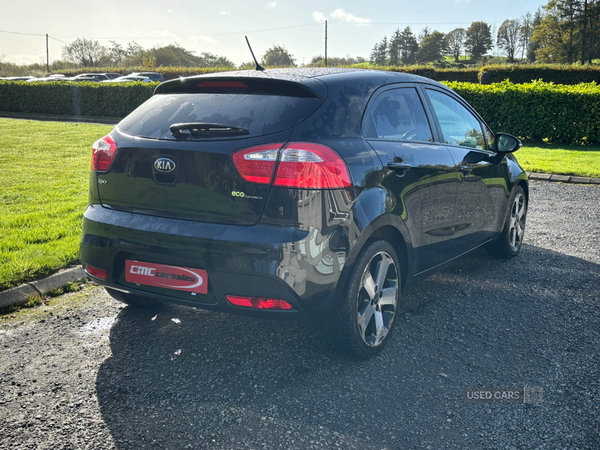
[0,119,112,289]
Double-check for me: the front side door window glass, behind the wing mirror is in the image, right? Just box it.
[426,89,486,150]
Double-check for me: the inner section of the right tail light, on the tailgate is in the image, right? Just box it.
[233,144,283,184]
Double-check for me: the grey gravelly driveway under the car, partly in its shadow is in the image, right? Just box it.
[0,182,600,450]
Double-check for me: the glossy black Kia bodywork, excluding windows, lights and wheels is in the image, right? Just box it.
[81,69,528,318]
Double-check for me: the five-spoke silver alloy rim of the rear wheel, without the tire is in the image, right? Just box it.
[357,251,398,347]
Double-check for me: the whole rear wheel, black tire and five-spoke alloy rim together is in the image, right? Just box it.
[325,240,401,358]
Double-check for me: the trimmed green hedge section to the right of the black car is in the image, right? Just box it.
[444,81,600,144]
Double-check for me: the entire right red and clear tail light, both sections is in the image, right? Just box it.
[233,142,352,189]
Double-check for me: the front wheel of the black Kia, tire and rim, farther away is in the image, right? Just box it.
[487,186,528,259]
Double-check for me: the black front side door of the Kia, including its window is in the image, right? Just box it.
[424,86,506,251]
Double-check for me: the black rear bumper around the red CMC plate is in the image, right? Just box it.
[81,205,345,319]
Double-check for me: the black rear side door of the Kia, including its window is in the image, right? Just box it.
[363,84,457,274]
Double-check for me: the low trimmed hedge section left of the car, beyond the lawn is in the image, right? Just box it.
[0,81,158,117]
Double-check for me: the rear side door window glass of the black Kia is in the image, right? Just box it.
[363,88,433,142]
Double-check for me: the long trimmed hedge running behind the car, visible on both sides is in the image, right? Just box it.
[0,81,600,144]
